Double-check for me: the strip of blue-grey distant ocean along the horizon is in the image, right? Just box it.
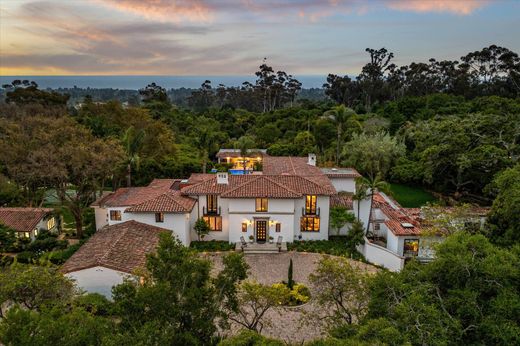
[0,75,326,90]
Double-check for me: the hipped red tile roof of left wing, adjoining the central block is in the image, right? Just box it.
[125,191,196,213]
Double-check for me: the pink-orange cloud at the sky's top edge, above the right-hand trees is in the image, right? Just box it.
[387,0,489,15]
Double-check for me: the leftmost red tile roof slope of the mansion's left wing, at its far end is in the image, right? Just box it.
[92,179,179,207]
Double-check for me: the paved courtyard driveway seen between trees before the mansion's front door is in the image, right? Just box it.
[201,251,377,343]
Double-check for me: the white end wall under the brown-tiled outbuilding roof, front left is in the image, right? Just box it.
[65,267,132,299]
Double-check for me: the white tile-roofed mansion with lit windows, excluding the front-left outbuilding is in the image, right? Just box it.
[85,153,442,270]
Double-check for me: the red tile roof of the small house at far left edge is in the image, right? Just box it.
[0,208,54,232]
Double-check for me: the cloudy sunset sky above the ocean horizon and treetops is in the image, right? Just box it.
[0,0,520,75]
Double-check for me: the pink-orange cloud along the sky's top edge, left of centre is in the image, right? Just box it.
[98,0,213,22]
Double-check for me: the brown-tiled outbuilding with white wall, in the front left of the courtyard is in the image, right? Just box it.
[61,221,166,298]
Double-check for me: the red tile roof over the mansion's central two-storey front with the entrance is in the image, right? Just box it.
[181,175,336,198]
